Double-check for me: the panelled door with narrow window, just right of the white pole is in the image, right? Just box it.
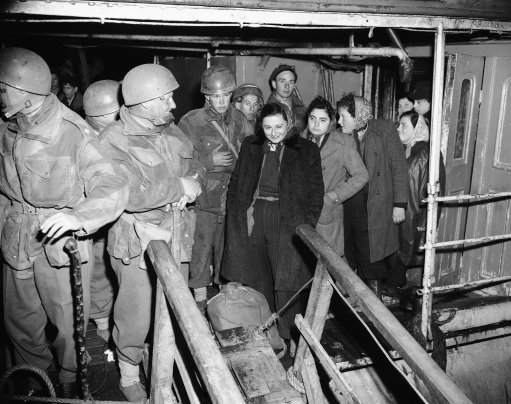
[436,54,485,284]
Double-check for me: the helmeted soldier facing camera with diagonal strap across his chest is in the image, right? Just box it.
[179,65,253,311]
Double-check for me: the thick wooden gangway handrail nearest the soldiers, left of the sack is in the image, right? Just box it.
[147,240,245,404]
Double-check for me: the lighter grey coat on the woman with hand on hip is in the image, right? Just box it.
[302,130,368,256]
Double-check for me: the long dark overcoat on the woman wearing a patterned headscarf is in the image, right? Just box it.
[363,119,408,262]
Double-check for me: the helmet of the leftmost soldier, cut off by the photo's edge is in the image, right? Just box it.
[0,47,51,95]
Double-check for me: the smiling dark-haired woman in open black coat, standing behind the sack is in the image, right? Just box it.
[222,103,324,339]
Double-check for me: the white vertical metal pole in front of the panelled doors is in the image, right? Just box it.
[421,23,445,339]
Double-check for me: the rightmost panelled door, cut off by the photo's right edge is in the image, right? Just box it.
[463,57,511,288]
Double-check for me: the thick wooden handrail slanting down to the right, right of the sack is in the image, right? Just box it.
[297,225,472,404]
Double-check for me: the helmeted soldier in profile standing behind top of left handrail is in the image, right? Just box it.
[101,64,205,402]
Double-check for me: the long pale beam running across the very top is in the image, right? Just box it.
[4,0,511,32]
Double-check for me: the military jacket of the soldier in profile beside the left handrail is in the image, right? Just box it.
[100,107,205,263]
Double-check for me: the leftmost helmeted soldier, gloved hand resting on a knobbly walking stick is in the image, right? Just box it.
[0,48,128,396]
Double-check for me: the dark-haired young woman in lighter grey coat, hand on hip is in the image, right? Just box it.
[302,97,368,256]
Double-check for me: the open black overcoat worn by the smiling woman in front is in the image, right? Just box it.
[222,129,324,291]
